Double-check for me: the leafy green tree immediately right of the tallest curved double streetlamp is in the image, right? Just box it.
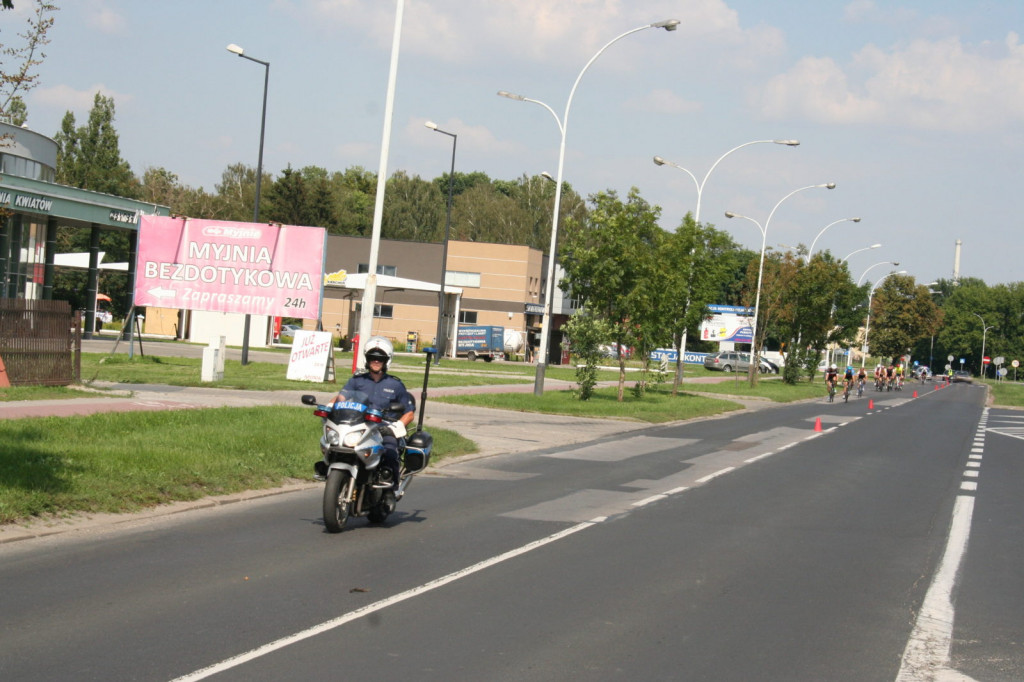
[561,187,666,400]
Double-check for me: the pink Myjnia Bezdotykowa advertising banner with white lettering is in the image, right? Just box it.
[135,215,326,319]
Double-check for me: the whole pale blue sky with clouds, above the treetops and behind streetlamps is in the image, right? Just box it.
[14,0,1024,285]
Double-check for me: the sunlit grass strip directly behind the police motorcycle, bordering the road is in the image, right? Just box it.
[0,407,476,523]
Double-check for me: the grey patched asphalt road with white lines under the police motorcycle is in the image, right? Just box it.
[0,378,1024,681]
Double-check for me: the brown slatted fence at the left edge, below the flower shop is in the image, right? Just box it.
[0,298,82,386]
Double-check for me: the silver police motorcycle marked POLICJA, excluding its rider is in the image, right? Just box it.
[301,348,433,532]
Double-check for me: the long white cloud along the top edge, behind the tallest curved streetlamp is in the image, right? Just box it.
[284,0,783,70]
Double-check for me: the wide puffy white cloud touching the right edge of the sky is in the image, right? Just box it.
[757,33,1024,132]
